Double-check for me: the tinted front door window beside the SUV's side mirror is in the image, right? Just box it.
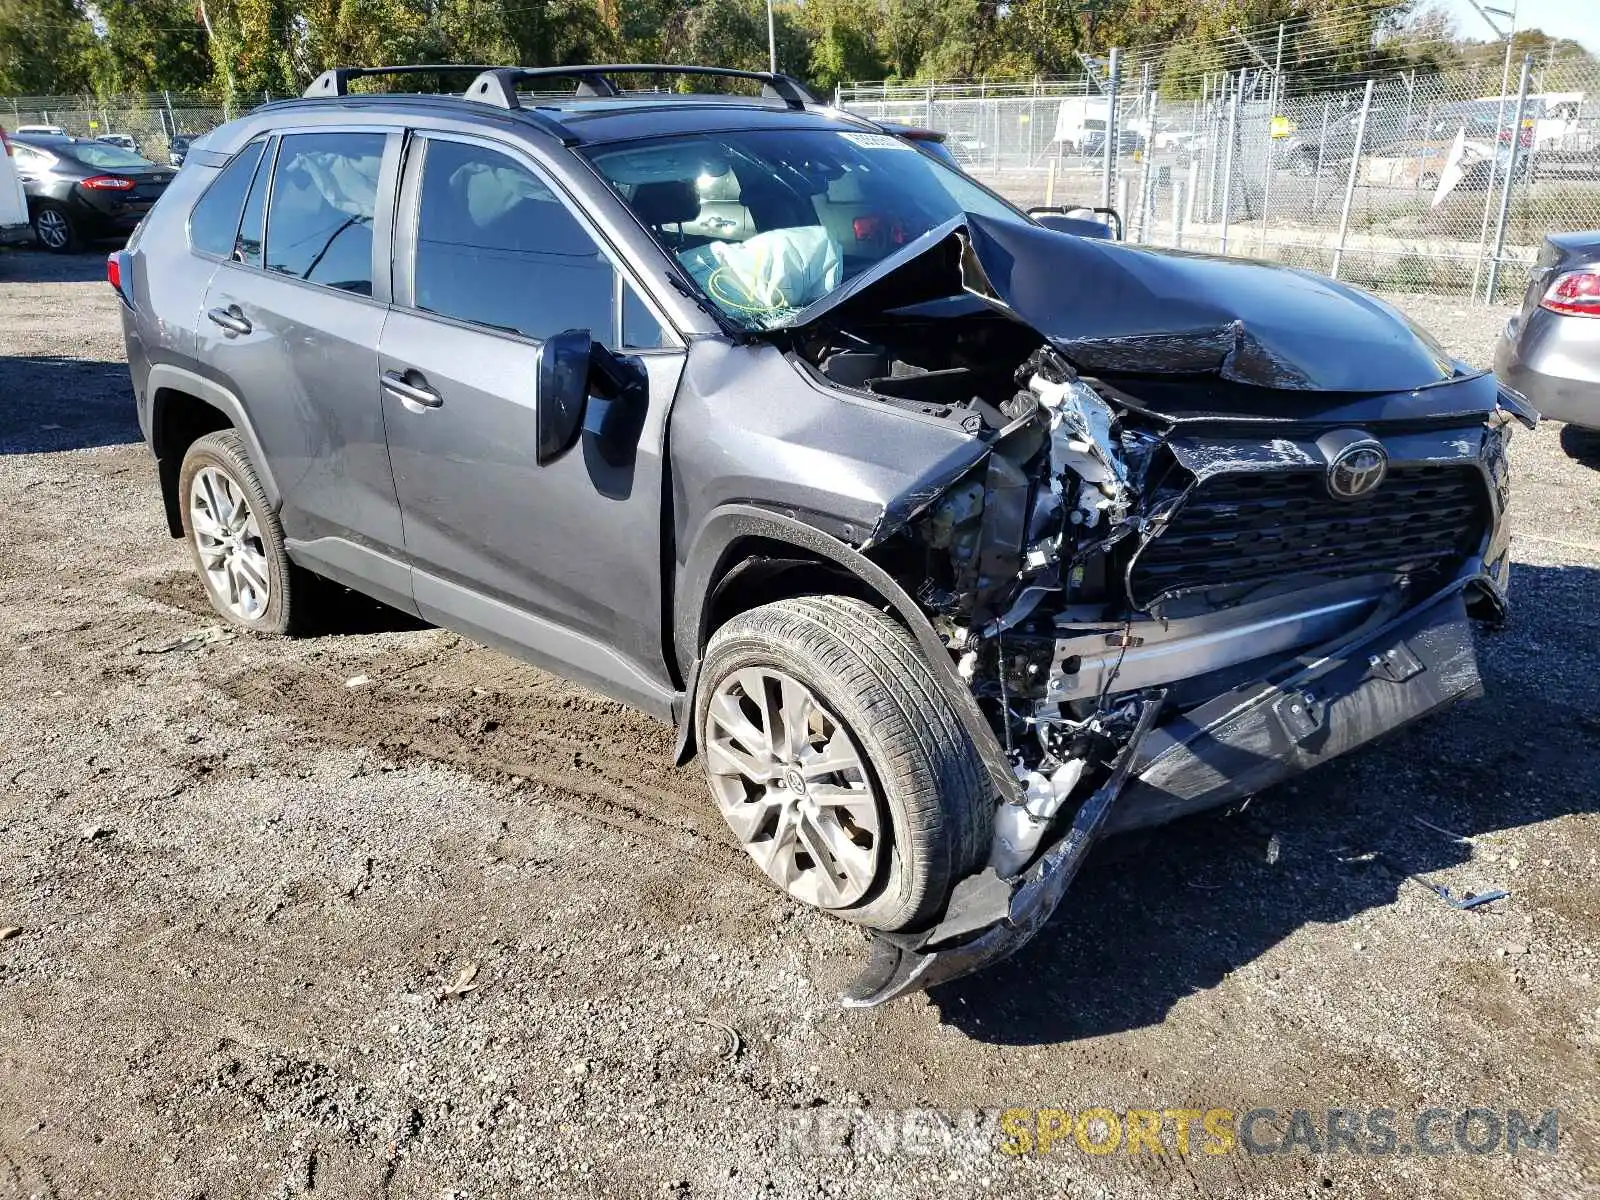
[413,138,614,346]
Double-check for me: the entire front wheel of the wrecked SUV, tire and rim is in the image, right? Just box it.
[694,595,994,930]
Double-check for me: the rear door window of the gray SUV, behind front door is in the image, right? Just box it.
[266,131,384,296]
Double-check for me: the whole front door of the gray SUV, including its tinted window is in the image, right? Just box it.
[378,136,683,712]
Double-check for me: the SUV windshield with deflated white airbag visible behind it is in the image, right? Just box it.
[589,130,1026,330]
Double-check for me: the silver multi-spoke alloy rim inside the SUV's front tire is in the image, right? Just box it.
[702,667,883,909]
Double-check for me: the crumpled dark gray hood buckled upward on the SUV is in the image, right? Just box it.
[786,213,1458,392]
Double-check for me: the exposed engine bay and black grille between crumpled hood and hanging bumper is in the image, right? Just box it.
[795,294,1499,878]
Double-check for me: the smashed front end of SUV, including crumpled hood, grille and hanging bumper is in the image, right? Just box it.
[774,216,1530,1005]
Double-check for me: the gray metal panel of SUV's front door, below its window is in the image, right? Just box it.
[378,310,682,710]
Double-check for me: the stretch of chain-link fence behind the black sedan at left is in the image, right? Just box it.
[0,91,252,162]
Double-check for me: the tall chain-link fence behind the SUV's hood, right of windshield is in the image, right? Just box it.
[837,56,1600,299]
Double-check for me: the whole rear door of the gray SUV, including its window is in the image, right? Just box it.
[200,131,403,563]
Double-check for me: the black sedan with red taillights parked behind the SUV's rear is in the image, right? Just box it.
[13,136,176,254]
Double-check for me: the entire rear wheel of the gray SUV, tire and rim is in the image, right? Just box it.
[178,429,306,634]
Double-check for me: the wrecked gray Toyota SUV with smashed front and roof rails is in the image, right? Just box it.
[110,66,1538,1005]
